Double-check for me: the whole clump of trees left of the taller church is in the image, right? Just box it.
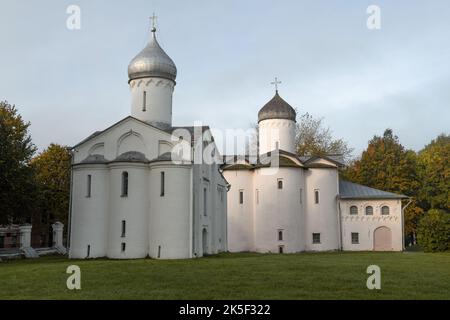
[0,101,71,225]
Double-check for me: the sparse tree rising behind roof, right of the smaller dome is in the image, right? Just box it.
[295,113,353,161]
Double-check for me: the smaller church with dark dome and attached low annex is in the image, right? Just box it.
[222,89,406,253]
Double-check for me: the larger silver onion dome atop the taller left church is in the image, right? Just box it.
[128,28,177,81]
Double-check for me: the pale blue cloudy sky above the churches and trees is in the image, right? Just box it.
[0,0,450,155]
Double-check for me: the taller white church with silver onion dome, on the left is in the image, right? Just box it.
[69,24,228,259]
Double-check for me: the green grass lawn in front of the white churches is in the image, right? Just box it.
[0,252,450,299]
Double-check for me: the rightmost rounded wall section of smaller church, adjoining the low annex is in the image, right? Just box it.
[304,168,339,251]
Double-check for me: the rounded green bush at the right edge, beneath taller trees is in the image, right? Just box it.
[417,209,450,252]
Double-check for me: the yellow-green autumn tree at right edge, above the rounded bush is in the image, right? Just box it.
[418,134,450,212]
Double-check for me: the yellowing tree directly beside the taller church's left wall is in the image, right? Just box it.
[31,143,71,225]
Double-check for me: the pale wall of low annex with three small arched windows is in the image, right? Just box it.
[340,199,403,251]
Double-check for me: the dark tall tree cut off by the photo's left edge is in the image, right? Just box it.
[0,101,36,224]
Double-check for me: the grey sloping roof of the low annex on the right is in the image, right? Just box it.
[339,180,408,199]
